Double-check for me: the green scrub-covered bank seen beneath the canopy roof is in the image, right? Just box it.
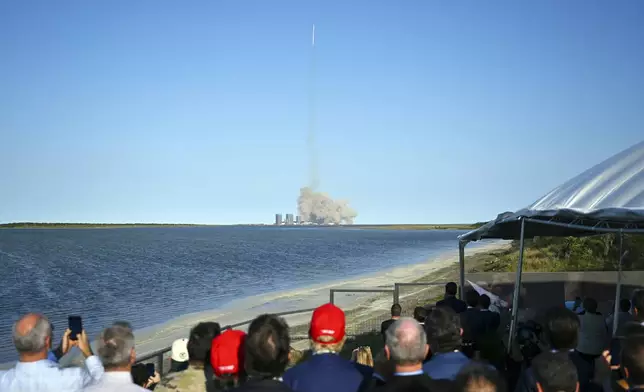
[479,234,644,272]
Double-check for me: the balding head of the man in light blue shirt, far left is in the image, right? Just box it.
[13,313,51,354]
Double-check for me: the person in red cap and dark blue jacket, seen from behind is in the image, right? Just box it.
[283,304,373,392]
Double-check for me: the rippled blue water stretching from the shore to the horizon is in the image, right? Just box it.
[0,227,461,363]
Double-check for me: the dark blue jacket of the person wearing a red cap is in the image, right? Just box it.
[283,354,373,392]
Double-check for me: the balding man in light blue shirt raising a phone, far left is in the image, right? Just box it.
[0,313,104,392]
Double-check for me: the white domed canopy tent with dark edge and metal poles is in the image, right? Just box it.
[459,141,644,346]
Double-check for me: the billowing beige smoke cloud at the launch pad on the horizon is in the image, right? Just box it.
[297,187,358,225]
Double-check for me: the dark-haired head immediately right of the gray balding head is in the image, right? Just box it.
[425,307,463,353]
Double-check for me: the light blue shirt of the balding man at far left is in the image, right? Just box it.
[0,356,104,392]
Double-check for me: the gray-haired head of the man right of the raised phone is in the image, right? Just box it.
[98,325,134,368]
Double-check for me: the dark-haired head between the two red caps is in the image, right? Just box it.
[244,314,296,378]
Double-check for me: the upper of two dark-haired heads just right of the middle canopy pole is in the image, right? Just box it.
[544,307,579,350]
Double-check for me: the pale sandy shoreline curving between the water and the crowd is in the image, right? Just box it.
[0,241,508,369]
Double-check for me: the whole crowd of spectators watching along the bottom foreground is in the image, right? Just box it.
[0,283,644,392]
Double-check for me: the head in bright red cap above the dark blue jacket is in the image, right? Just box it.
[309,303,346,353]
